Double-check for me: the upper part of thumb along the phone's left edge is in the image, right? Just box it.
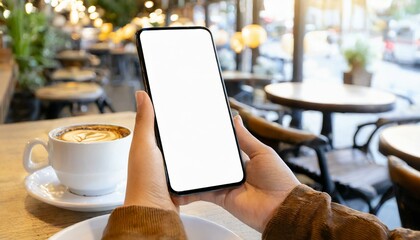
[133,91,156,145]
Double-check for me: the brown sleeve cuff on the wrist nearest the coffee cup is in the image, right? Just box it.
[102,206,187,240]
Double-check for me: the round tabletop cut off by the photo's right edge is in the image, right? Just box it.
[379,124,420,171]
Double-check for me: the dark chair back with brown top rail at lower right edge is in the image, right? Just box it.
[388,156,420,230]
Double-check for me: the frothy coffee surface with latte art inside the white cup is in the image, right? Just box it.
[55,124,130,143]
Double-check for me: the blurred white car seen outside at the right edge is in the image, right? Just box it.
[383,27,420,64]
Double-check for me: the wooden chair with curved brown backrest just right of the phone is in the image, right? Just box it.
[238,109,393,214]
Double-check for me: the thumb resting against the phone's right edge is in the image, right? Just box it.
[234,115,267,159]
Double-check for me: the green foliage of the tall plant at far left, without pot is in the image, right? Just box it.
[2,0,68,91]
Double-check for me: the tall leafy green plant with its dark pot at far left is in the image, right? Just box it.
[3,0,68,122]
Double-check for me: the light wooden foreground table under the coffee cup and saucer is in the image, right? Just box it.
[0,112,261,239]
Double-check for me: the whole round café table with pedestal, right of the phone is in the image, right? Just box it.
[264,82,396,146]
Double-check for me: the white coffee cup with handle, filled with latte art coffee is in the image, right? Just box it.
[23,124,132,196]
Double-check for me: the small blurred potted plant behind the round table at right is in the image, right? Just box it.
[343,39,374,87]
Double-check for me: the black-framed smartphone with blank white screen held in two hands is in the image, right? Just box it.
[136,27,245,195]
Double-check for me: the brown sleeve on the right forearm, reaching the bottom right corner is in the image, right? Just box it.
[263,184,420,240]
